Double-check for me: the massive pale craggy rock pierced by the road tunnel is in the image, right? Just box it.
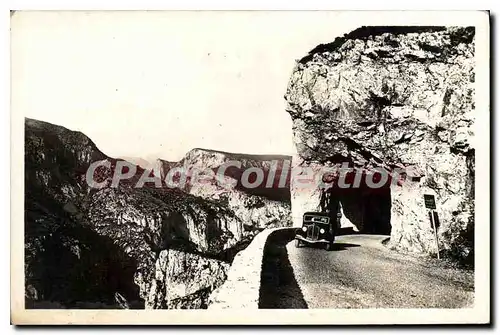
[285,27,475,262]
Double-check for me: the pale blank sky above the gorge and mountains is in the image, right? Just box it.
[12,12,359,160]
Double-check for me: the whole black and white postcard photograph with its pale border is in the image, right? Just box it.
[10,10,490,324]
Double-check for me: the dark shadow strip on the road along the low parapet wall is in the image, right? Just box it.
[259,237,307,309]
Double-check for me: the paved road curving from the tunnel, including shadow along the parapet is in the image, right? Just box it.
[262,235,474,308]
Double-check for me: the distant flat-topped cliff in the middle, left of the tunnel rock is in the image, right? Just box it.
[156,149,291,236]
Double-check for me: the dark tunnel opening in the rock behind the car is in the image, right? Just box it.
[320,178,391,235]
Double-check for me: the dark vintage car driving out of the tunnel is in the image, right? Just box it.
[295,212,337,250]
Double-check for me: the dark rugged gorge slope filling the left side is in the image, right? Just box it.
[25,119,290,308]
